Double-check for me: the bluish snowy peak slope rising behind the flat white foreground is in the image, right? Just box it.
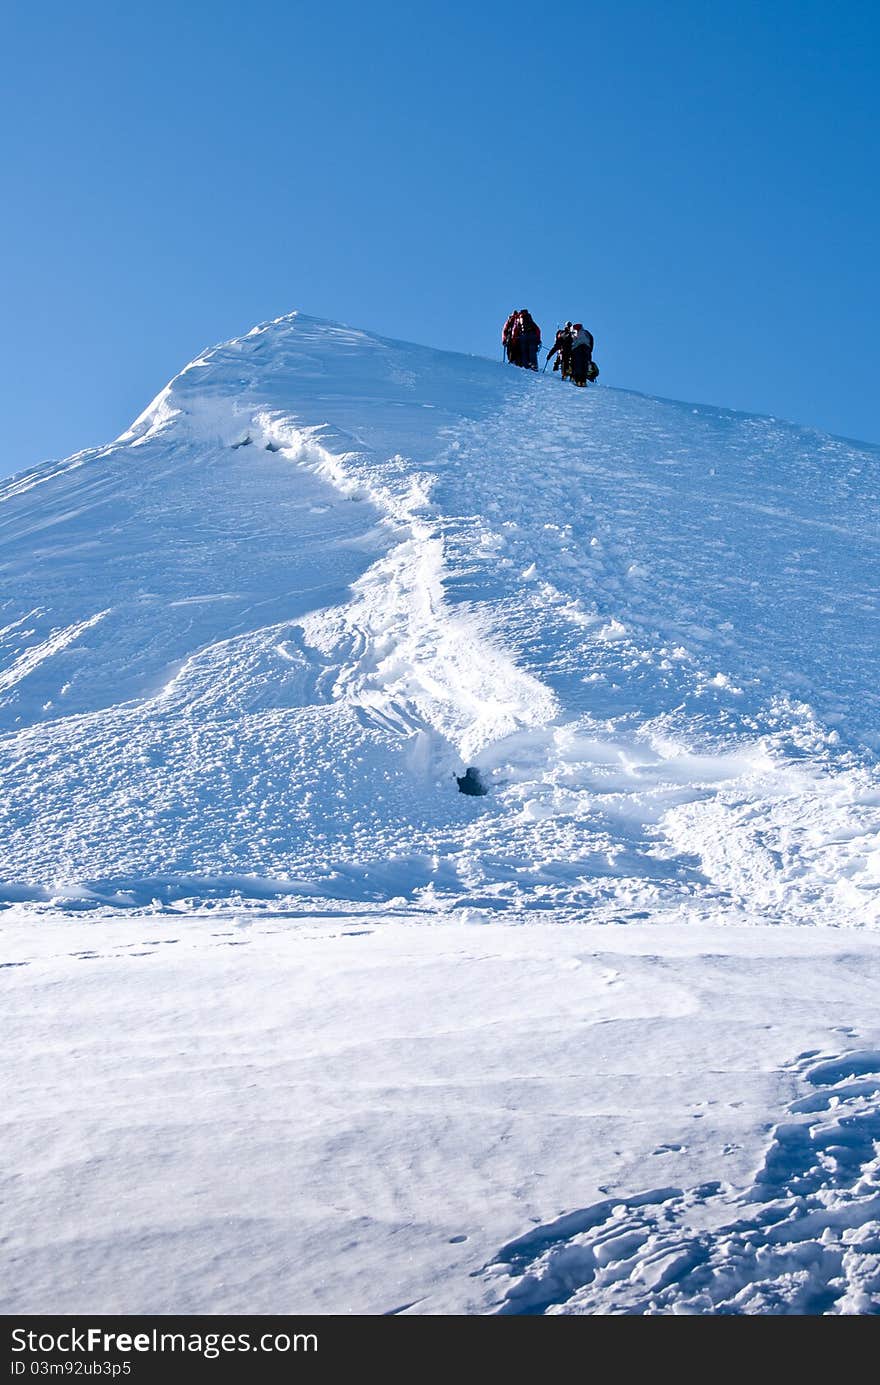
[0,314,880,924]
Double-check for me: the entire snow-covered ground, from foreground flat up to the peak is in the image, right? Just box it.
[0,314,880,1313]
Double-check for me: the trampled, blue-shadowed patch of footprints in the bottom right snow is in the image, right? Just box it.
[484,1050,880,1316]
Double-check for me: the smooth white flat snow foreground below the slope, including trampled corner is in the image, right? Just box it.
[3,906,880,1313]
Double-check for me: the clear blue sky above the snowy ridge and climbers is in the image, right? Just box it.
[0,0,880,474]
